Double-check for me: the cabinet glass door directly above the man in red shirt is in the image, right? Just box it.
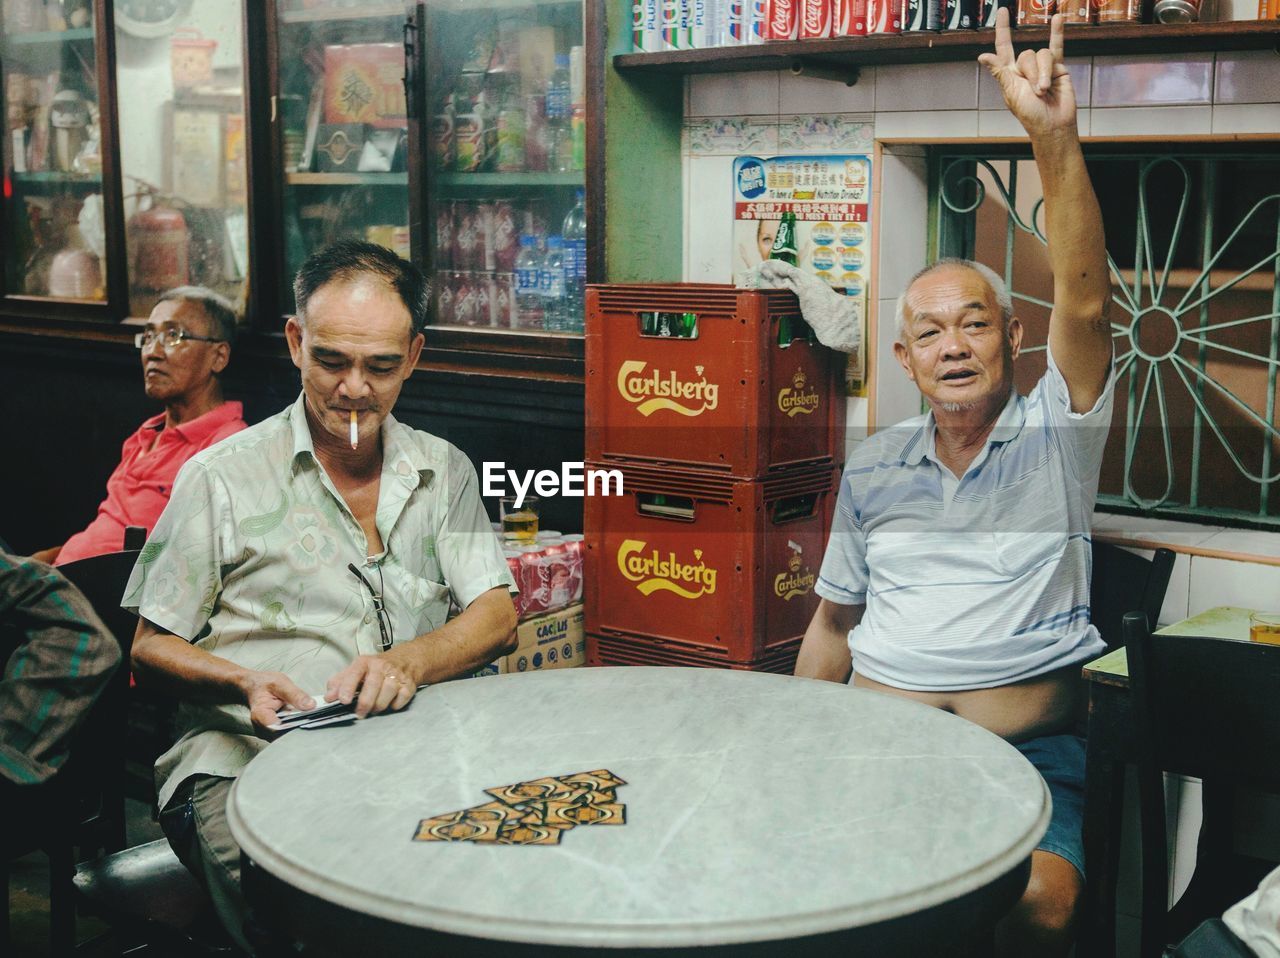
[114,0,248,316]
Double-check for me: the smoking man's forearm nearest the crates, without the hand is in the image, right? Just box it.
[399,587,516,685]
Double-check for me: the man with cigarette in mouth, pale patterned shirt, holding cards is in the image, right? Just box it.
[124,242,516,944]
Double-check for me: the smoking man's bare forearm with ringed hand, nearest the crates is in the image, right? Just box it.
[325,585,516,717]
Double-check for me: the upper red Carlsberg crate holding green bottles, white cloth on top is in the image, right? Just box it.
[586,283,845,479]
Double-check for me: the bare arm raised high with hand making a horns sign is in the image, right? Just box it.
[978,9,1111,412]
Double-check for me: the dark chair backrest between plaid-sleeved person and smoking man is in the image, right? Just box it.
[58,549,138,850]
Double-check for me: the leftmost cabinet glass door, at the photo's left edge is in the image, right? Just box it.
[0,0,106,302]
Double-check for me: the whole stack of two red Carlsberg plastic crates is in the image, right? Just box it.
[584,284,845,672]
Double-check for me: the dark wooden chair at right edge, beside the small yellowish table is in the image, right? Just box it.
[1124,612,1280,958]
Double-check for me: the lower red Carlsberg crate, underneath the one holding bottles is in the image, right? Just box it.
[585,464,837,663]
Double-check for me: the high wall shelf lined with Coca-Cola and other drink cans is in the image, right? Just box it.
[613,0,1280,73]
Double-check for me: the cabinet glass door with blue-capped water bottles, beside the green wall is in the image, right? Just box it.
[424,0,586,334]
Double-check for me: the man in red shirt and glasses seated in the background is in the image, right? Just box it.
[35,286,244,565]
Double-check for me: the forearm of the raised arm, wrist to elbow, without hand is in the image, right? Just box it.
[1032,126,1111,321]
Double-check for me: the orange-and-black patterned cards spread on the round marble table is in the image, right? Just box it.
[413,768,627,845]
